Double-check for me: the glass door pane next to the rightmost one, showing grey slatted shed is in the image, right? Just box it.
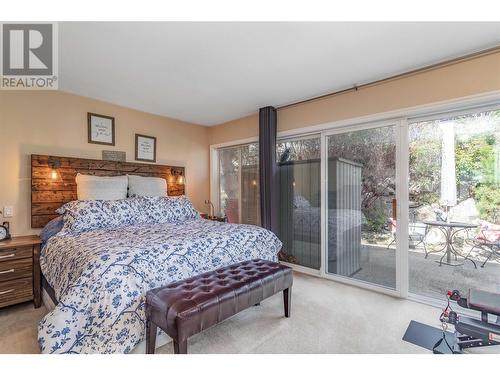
[326,125,396,289]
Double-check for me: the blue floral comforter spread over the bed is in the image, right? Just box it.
[38,219,281,353]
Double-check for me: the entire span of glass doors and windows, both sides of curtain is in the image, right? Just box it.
[214,101,500,299]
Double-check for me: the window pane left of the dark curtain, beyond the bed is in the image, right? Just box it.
[216,143,260,225]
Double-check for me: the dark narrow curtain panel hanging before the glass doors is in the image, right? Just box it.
[259,107,279,234]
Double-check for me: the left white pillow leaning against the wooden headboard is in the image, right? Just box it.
[76,173,128,200]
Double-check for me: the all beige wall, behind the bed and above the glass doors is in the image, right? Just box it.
[0,52,500,235]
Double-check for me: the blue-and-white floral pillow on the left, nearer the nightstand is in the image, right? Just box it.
[57,198,146,233]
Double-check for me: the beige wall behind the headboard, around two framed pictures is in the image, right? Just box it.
[0,91,209,235]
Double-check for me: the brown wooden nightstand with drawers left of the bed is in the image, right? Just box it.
[0,236,42,308]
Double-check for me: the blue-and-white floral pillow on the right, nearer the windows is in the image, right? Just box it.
[142,196,200,224]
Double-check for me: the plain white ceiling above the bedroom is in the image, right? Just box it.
[59,22,500,125]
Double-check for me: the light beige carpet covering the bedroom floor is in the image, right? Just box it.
[0,273,488,353]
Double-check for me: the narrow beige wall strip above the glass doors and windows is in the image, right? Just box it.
[209,52,500,144]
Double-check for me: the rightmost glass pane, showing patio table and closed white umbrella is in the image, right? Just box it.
[408,109,500,299]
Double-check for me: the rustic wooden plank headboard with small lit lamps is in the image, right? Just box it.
[31,155,185,228]
